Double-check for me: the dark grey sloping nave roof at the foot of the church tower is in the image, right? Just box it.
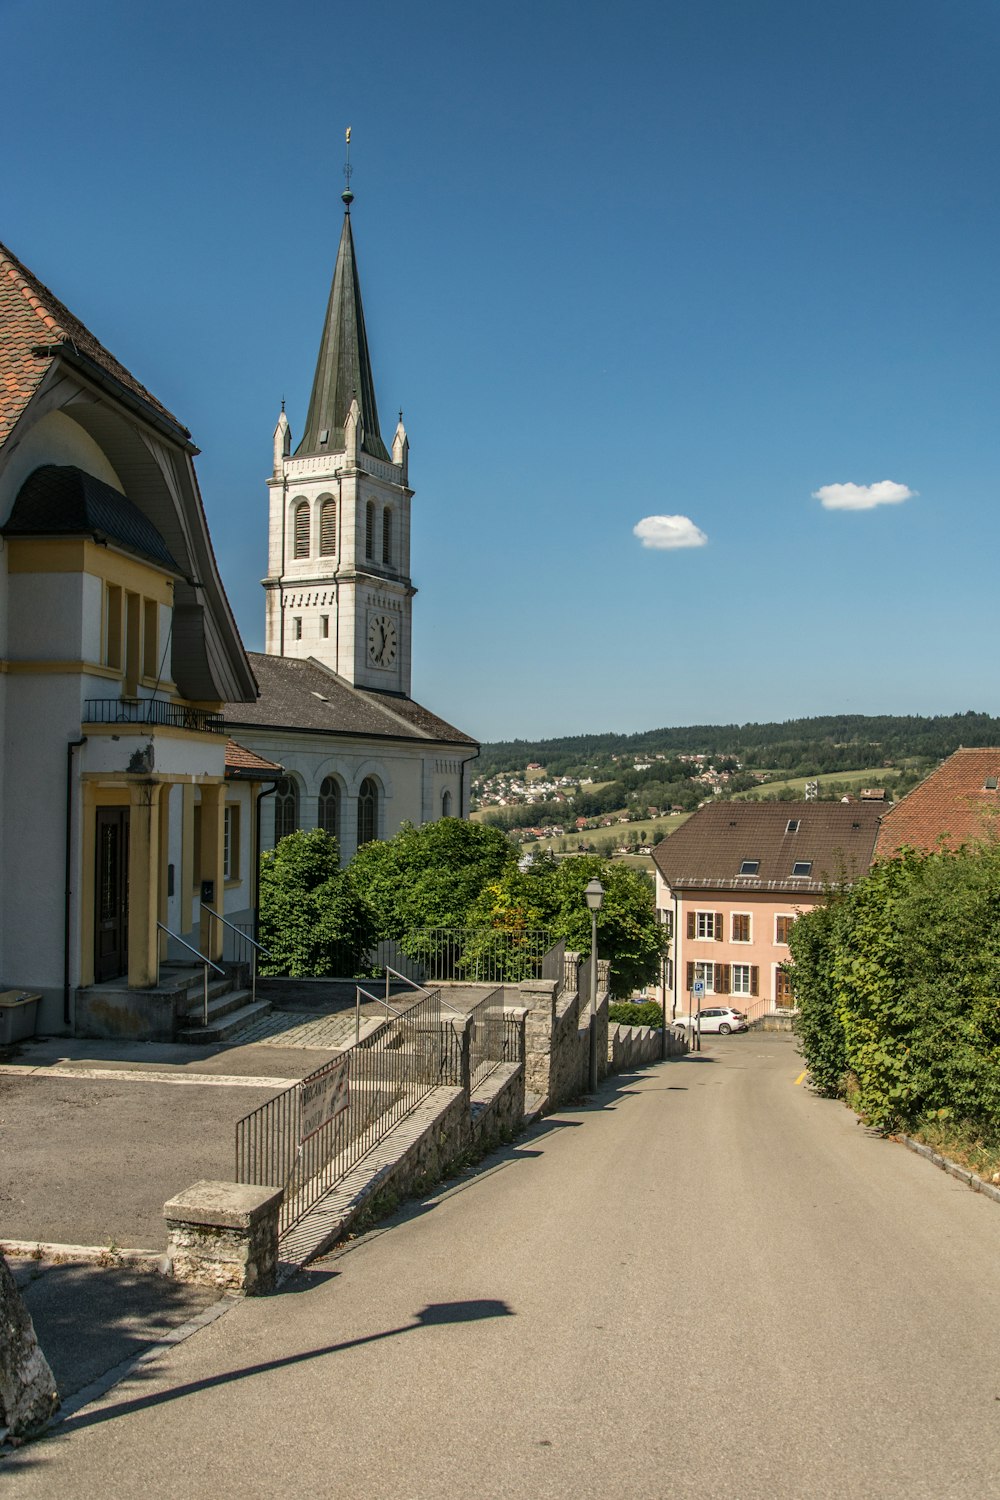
[223,651,477,747]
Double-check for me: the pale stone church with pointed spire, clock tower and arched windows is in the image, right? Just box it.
[225,175,478,863]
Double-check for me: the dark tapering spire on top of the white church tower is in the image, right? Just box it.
[295,210,388,462]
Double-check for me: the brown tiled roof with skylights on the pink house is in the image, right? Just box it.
[652,803,880,894]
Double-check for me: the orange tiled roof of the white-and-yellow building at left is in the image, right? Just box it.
[0,245,187,446]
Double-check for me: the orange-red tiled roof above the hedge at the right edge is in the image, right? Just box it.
[876,747,1000,860]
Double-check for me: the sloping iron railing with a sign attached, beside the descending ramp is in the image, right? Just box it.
[235,990,443,1235]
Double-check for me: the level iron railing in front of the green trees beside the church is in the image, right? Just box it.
[402,927,565,984]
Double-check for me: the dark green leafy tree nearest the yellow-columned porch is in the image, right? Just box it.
[261,828,375,978]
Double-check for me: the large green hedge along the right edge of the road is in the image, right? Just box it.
[790,843,1000,1131]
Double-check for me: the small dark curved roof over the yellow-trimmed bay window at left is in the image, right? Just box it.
[3,464,180,573]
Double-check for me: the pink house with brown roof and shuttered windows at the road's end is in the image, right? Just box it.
[652,803,882,1017]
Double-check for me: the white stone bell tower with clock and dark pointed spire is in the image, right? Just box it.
[262,131,415,696]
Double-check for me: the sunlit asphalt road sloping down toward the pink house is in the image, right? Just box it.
[0,1037,1000,1500]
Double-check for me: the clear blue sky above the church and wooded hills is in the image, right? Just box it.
[7,0,1000,740]
